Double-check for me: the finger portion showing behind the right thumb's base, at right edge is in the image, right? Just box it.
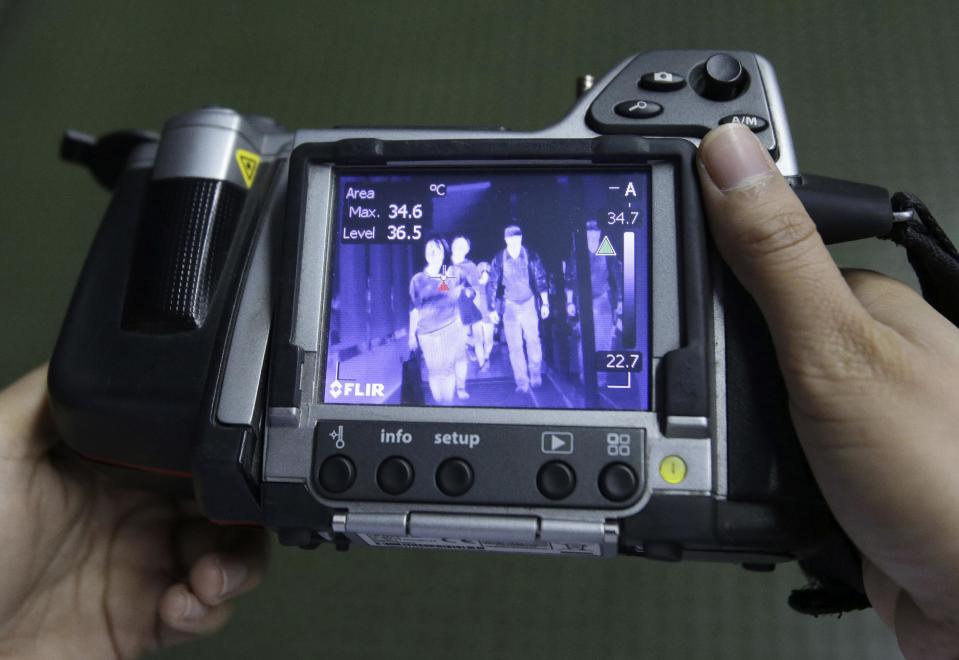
[842,269,957,354]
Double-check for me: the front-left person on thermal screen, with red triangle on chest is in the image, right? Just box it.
[409,238,469,404]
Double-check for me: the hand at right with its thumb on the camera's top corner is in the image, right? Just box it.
[698,124,959,660]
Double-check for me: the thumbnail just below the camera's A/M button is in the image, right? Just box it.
[699,124,775,191]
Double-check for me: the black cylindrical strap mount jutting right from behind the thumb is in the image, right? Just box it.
[789,174,893,244]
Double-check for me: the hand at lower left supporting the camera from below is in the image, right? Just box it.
[0,367,267,658]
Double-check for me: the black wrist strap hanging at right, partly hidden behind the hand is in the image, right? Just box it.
[789,192,959,616]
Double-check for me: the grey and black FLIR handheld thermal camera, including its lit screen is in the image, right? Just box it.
[49,51,891,564]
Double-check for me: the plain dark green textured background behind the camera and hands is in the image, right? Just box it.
[0,0,959,660]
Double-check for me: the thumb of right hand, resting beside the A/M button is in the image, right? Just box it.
[697,124,868,360]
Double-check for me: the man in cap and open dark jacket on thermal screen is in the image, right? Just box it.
[489,225,549,393]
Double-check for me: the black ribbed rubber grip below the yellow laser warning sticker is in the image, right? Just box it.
[123,178,246,333]
